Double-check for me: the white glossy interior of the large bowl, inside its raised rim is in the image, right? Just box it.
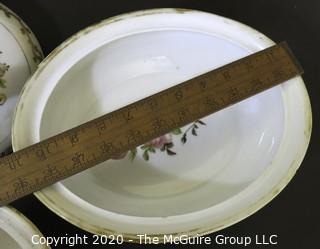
[40,30,284,217]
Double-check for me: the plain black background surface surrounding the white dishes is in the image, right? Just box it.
[2,0,320,249]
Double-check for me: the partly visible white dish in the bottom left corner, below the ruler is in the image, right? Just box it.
[0,207,48,249]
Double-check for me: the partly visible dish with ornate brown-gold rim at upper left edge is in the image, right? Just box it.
[0,3,43,153]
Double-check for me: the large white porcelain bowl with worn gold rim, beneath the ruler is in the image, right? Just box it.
[12,9,311,240]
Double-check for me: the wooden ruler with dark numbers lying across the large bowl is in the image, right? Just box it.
[0,43,303,205]
